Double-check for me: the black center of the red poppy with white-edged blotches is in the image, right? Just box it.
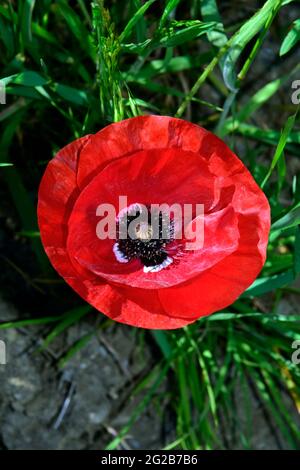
[114,204,174,272]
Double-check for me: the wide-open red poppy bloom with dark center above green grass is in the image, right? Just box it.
[38,116,270,329]
